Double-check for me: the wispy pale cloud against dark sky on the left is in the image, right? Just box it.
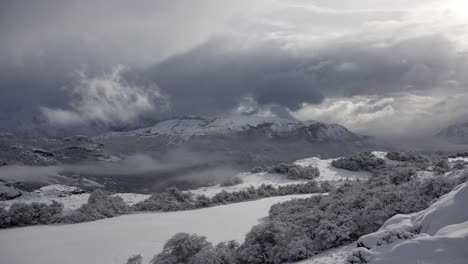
[41,66,167,126]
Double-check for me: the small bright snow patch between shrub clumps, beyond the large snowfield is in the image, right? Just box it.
[294,157,371,181]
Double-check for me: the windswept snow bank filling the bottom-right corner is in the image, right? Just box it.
[358,183,468,264]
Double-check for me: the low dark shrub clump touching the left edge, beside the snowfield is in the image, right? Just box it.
[0,201,63,228]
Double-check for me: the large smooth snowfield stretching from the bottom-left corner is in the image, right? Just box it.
[0,194,318,264]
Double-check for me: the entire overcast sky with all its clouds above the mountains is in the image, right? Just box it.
[0,0,468,138]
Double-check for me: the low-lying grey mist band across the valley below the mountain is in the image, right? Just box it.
[0,151,241,193]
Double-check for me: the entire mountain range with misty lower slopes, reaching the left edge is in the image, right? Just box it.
[0,116,369,192]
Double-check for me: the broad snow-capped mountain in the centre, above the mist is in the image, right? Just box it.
[98,116,366,161]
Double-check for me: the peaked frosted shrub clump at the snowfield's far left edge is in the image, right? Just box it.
[60,190,130,223]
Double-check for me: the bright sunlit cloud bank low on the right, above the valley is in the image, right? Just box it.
[293,90,468,139]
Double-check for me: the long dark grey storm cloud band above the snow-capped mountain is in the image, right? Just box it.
[124,35,466,115]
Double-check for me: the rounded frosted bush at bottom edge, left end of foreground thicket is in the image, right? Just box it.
[150,233,212,264]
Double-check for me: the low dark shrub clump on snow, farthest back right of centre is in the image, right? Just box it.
[331,152,385,171]
